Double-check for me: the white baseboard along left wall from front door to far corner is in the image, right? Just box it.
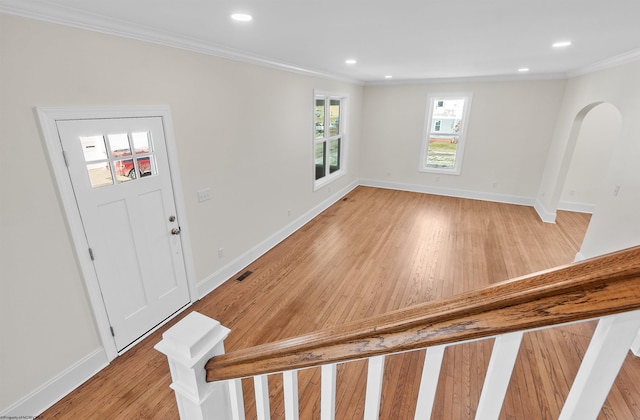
[197,182,359,299]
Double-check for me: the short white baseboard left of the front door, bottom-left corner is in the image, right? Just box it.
[0,348,109,419]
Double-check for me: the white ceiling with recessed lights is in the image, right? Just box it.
[0,0,640,83]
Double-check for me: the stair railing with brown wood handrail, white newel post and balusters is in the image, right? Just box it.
[156,247,640,420]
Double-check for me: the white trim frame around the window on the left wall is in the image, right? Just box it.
[311,90,349,191]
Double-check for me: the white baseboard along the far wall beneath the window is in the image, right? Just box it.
[360,179,534,206]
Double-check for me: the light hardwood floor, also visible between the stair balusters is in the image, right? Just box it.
[43,187,640,420]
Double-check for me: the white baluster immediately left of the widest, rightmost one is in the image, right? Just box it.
[476,332,523,420]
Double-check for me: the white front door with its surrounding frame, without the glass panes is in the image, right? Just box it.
[37,107,195,360]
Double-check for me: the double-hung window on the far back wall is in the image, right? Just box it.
[420,93,471,175]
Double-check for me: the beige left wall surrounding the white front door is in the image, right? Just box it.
[0,14,363,414]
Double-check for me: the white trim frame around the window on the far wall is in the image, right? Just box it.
[418,92,473,175]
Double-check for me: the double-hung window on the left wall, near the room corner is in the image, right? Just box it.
[313,91,346,189]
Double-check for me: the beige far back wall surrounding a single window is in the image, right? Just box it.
[360,80,566,198]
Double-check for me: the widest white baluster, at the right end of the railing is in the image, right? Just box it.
[559,311,640,420]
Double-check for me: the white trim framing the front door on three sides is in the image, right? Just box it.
[35,106,197,361]
